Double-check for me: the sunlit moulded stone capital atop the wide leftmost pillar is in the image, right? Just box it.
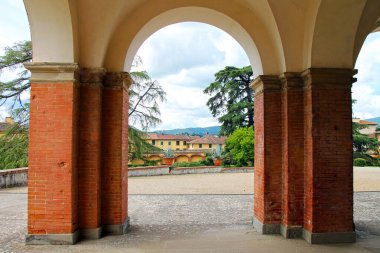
[24,62,78,84]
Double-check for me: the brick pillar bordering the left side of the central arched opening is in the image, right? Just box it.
[102,72,132,234]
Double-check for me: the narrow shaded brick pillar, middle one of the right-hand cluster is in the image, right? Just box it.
[280,73,304,238]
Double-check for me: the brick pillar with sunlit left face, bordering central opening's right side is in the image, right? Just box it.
[251,75,282,234]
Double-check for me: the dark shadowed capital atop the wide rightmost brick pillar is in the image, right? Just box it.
[301,68,358,89]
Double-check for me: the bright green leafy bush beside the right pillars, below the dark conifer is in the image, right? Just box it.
[223,126,255,167]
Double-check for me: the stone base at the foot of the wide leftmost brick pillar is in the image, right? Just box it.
[25,231,79,245]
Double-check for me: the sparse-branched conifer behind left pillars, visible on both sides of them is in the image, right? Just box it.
[0,41,166,168]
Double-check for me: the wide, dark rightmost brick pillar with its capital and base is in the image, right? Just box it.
[302,69,356,243]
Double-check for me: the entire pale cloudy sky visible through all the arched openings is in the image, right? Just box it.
[0,0,380,130]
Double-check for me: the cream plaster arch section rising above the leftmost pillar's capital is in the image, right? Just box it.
[24,0,78,63]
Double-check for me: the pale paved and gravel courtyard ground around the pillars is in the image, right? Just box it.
[0,168,380,253]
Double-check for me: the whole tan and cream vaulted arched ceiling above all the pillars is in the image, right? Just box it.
[24,0,380,74]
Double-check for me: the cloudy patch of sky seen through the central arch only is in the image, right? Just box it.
[137,22,249,129]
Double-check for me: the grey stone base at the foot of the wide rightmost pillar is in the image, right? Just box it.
[302,229,356,244]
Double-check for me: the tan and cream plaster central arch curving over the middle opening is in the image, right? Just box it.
[104,0,285,75]
